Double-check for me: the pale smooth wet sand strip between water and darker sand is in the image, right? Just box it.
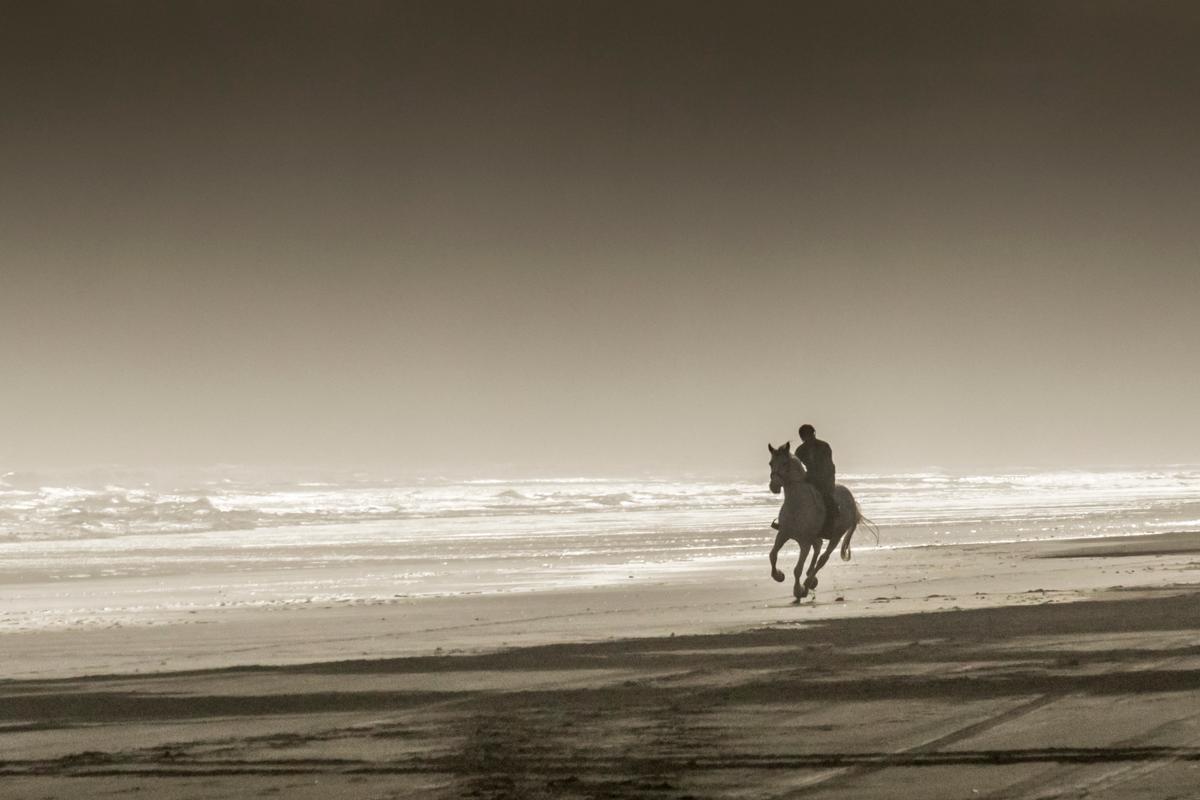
[0,531,1200,680]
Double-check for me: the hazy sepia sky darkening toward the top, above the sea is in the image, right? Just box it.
[0,0,1200,476]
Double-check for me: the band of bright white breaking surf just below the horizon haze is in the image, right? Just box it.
[0,468,1200,541]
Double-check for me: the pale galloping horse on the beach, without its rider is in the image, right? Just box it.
[767,441,863,602]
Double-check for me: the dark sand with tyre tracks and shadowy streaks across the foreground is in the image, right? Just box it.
[0,534,1200,800]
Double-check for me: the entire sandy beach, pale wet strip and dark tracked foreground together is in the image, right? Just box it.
[0,533,1200,800]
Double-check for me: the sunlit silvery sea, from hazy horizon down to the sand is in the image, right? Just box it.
[0,467,1200,630]
